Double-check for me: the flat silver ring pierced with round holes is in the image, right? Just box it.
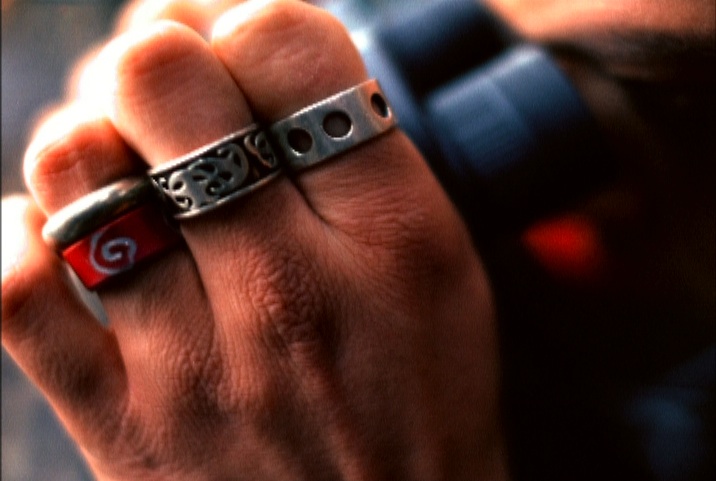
[268,79,396,171]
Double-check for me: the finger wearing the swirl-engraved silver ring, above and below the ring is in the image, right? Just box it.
[89,21,330,378]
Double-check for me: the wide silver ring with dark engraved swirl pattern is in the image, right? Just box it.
[149,125,281,219]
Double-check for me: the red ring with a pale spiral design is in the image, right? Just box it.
[62,204,181,289]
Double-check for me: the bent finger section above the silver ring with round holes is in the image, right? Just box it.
[213,0,366,111]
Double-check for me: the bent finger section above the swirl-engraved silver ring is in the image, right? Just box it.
[93,17,248,159]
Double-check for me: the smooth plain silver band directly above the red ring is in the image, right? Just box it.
[42,177,157,250]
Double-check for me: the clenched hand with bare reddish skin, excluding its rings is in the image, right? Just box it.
[2,0,505,480]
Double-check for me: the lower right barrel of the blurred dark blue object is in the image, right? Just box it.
[423,45,610,225]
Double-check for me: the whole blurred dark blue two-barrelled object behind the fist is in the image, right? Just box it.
[350,0,611,228]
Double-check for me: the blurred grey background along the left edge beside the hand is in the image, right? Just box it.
[0,0,121,481]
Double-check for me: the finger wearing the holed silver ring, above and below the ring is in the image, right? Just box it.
[212,0,449,240]
